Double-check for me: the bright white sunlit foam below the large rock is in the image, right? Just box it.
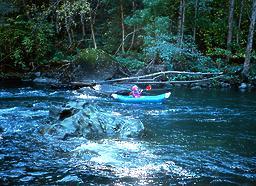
[70,140,196,183]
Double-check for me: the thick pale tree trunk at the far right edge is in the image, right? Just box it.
[242,0,256,79]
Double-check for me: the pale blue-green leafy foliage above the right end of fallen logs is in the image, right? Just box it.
[139,17,211,71]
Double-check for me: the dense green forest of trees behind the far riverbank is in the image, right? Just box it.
[0,0,256,82]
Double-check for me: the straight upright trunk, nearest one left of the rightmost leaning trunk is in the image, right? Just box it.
[227,0,235,53]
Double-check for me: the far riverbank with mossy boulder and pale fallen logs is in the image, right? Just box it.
[0,48,256,90]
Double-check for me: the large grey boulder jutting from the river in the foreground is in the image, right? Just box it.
[49,105,144,139]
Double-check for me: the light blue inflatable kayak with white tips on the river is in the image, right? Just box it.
[111,92,171,103]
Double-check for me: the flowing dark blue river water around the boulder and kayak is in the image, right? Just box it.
[0,83,256,185]
